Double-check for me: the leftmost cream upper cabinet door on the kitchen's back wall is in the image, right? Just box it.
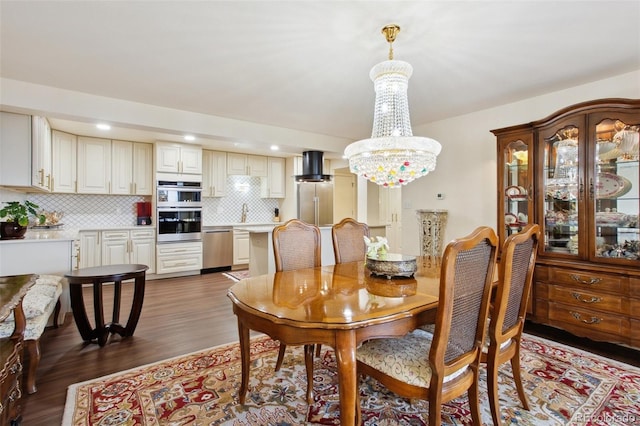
[51,130,78,193]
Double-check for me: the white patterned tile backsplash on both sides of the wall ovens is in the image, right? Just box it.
[23,176,279,229]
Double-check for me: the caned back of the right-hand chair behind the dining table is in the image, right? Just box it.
[331,217,369,264]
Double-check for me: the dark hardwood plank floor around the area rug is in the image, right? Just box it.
[22,273,640,426]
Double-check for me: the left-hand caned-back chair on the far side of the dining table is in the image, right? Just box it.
[272,219,322,403]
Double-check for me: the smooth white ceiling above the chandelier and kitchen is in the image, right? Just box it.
[0,0,640,158]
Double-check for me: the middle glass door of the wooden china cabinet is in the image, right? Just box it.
[541,124,584,255]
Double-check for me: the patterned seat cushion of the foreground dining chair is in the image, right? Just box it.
[356,329,467,388]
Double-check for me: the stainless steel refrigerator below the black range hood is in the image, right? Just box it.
[297,182,333,226]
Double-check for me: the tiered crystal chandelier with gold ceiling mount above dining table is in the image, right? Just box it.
[344,24,442,188]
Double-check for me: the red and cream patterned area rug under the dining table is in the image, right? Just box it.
[63,335,640,426]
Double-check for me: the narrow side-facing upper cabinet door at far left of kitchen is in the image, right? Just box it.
[31,115,51,192]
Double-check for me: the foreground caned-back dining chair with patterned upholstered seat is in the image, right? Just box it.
[356,226,498,425]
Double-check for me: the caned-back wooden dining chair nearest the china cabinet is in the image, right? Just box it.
[481,224,540,425]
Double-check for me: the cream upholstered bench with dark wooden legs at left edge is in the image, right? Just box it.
[0,275,63,394]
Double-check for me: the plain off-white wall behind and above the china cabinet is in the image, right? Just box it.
[402,70,640,255]
